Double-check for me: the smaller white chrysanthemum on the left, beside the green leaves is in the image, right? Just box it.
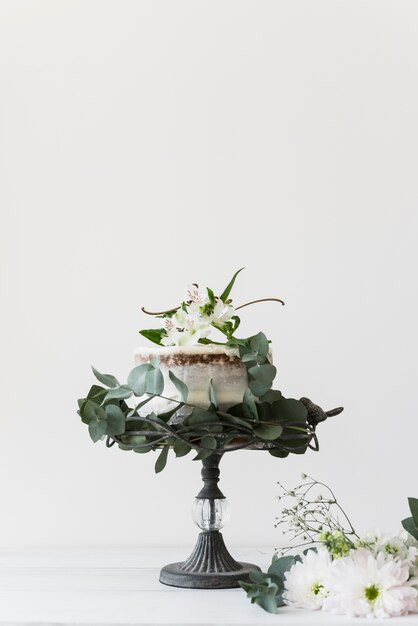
[283,548,331,610]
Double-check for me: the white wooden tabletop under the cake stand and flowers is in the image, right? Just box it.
[0,548,418,626]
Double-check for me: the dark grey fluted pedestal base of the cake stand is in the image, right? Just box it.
[160,530,260,589]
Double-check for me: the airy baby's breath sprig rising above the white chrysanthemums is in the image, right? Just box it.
[275,474,359,558]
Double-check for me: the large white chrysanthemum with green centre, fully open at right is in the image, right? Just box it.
[323,548,417,618]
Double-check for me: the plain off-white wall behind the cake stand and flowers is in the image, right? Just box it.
[0,0,418,547]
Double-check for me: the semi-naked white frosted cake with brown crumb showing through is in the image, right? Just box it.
[135,345,248,414]
